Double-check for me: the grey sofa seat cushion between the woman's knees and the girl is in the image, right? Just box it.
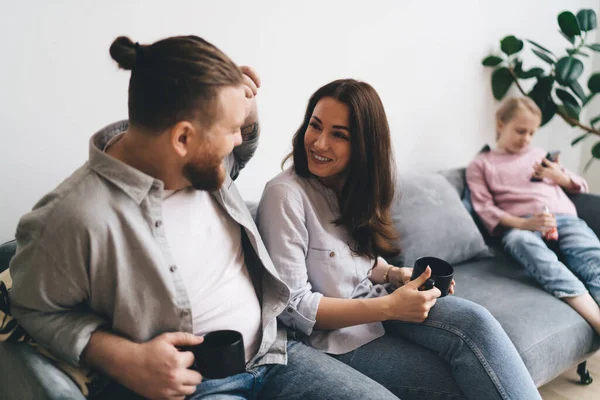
[455,250,600,386]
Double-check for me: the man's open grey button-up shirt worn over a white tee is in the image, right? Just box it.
[9,121,290,368]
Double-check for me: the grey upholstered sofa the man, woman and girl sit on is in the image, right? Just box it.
[0,169,600,400]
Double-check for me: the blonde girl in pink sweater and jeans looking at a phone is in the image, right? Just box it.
[467,97,600,332]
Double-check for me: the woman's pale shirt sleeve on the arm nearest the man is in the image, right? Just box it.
[257,184,323,335]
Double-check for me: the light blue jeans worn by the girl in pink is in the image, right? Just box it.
[502,215,600,304]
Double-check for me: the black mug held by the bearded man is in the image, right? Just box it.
[180,330,246,379]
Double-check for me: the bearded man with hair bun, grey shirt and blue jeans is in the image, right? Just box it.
[10,36,395,399]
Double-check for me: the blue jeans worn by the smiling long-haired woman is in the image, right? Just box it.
[336,296,540,400]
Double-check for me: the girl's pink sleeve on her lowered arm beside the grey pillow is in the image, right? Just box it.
[466,159,506,234]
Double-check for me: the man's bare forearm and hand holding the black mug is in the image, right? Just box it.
[82,331,204,400]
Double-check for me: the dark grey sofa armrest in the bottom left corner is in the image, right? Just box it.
[0,343,85,400]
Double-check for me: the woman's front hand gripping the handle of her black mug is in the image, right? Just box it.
[385,267,442,322]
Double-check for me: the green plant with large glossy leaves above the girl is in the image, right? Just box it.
[482,9,600,170]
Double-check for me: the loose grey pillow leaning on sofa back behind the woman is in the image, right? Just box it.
[388,173,488,266]
